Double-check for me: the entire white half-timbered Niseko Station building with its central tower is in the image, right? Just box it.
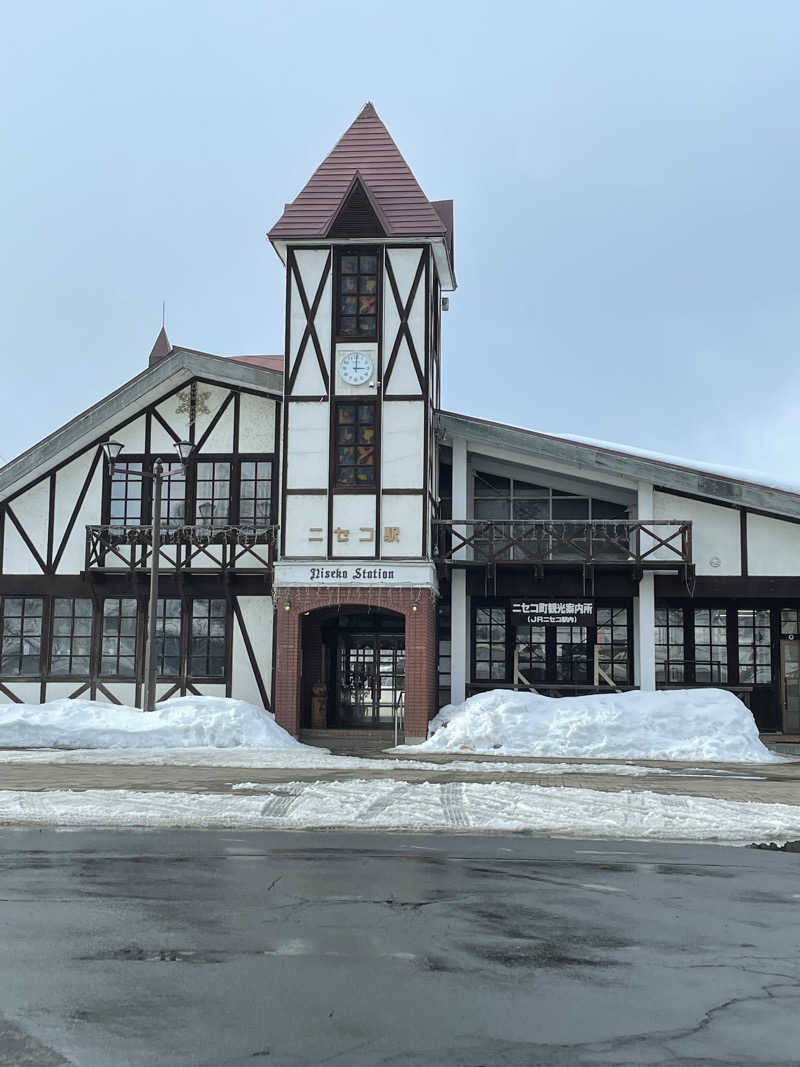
[0,103,800,740]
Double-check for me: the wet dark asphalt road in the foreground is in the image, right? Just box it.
[0,830,800,1067]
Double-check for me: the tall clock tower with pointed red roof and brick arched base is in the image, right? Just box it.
[269,103,455,738]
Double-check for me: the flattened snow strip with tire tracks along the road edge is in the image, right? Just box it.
[0,780,800,845]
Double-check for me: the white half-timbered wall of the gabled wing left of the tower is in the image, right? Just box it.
[0,379,281,707]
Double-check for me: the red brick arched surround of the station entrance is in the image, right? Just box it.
[275,586,436,738]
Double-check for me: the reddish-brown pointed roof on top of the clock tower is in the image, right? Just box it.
[269,102,447,240]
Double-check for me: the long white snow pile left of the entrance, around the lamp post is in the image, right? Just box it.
[0,697,300,749]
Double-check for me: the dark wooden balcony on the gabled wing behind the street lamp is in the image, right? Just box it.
[86,526,277,573]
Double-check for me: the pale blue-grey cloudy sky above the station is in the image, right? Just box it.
[0,0,800,480]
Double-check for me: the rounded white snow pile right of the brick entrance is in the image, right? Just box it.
[415,689,780,763]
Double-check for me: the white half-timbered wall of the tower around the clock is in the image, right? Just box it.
[281,241,439,559]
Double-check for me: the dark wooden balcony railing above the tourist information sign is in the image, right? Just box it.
[433,519,691,569]
